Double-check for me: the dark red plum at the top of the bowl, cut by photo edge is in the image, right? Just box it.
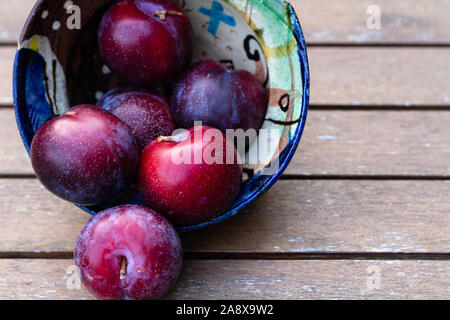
[98,0,193,87]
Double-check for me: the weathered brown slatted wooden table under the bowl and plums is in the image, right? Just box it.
[0,0,450,299]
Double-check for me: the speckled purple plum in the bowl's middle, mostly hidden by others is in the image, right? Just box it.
[97,87,176,151]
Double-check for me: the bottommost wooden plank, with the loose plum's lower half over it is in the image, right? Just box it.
[0,260,450,300]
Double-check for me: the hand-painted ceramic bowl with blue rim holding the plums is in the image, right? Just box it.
[14,0,309,231]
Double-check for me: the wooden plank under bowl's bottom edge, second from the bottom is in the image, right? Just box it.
[0,179,450,253]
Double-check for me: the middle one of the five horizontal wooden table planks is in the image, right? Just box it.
[0,109,450,176]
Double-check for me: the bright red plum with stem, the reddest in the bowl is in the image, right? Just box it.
[138,126,242,226]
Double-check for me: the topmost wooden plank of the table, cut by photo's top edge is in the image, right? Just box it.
[0,0,450,44]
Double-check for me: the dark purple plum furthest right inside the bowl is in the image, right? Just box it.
[170,60,268,133]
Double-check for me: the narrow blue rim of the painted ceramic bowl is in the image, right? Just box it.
[13,0,310,232]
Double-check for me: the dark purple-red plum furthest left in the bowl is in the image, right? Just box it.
[31,105,139,205]
